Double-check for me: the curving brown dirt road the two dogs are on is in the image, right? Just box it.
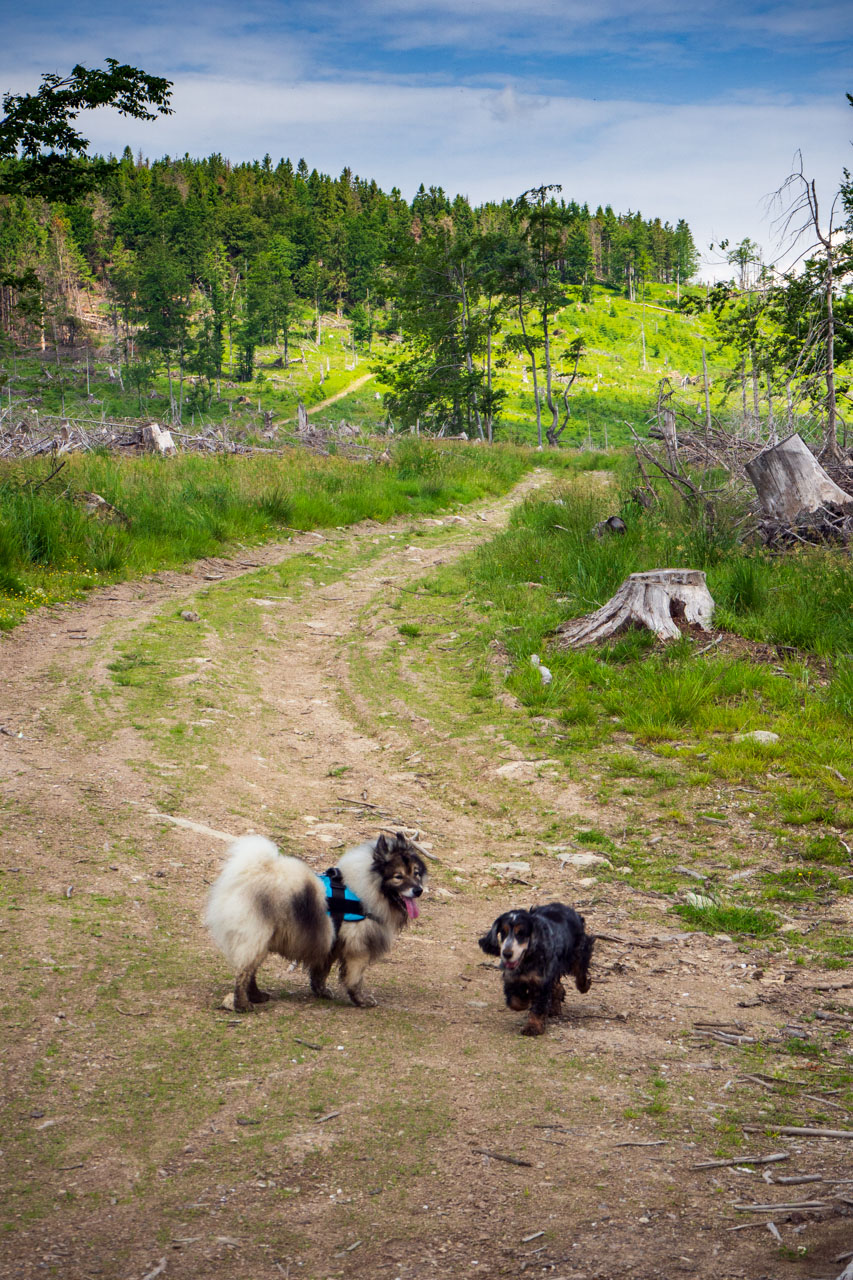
[0,475,853,1280]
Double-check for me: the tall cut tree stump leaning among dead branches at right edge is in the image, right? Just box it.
[745,433,853,524]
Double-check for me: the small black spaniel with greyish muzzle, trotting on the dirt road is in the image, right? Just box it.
[479,902,596,1036]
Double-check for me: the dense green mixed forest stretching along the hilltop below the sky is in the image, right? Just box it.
[0,142,697,426]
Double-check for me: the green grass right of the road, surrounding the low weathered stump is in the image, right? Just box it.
[335,463,853,942]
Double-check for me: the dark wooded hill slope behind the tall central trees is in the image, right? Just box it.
[0,150,695,398]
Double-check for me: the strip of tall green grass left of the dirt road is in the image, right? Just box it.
[0,439,534,628]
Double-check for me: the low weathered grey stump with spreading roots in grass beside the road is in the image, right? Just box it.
[557,568,713,649]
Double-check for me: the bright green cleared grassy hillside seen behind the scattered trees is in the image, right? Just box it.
[0,284,763,448]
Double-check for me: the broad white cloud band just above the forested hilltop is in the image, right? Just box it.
[68,77,853,274]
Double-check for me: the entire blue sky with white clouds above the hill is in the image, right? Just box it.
[0,0,853,278]
